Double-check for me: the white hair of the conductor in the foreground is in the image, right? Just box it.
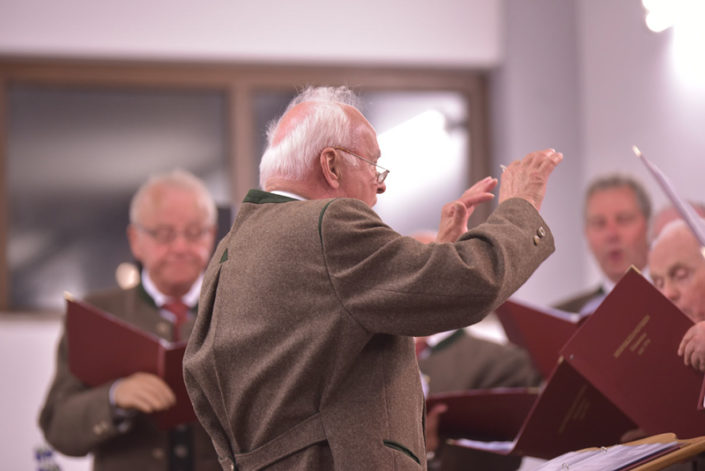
[259,87,359,189]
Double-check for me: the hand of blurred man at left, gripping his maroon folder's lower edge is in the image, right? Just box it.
[114,372,176,414]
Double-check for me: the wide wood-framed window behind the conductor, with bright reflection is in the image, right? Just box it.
[0,60,489,311]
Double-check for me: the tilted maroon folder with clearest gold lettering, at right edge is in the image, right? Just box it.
[561,269,705,439]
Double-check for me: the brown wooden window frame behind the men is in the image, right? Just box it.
[0,57,491,311]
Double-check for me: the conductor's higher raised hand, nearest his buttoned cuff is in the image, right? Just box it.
[499,149,563,210]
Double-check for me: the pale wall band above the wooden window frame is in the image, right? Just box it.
[0,0,502,66]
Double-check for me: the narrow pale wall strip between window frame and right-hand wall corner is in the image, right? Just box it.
[490,0,586,304]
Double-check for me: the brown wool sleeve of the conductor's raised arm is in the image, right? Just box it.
[319,198,554,336]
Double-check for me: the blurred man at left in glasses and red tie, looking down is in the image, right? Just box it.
[39,170,221,471]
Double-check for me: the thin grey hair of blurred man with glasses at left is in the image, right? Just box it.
[130,169,217,224]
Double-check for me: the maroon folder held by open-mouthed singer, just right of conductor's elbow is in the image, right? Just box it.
[495,299,586,379]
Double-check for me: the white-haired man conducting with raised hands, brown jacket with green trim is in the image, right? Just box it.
[184,88,562,471]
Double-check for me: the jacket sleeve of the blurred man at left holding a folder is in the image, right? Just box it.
[39,328,120,456]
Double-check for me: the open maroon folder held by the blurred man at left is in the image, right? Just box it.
[66,297,196,429]
